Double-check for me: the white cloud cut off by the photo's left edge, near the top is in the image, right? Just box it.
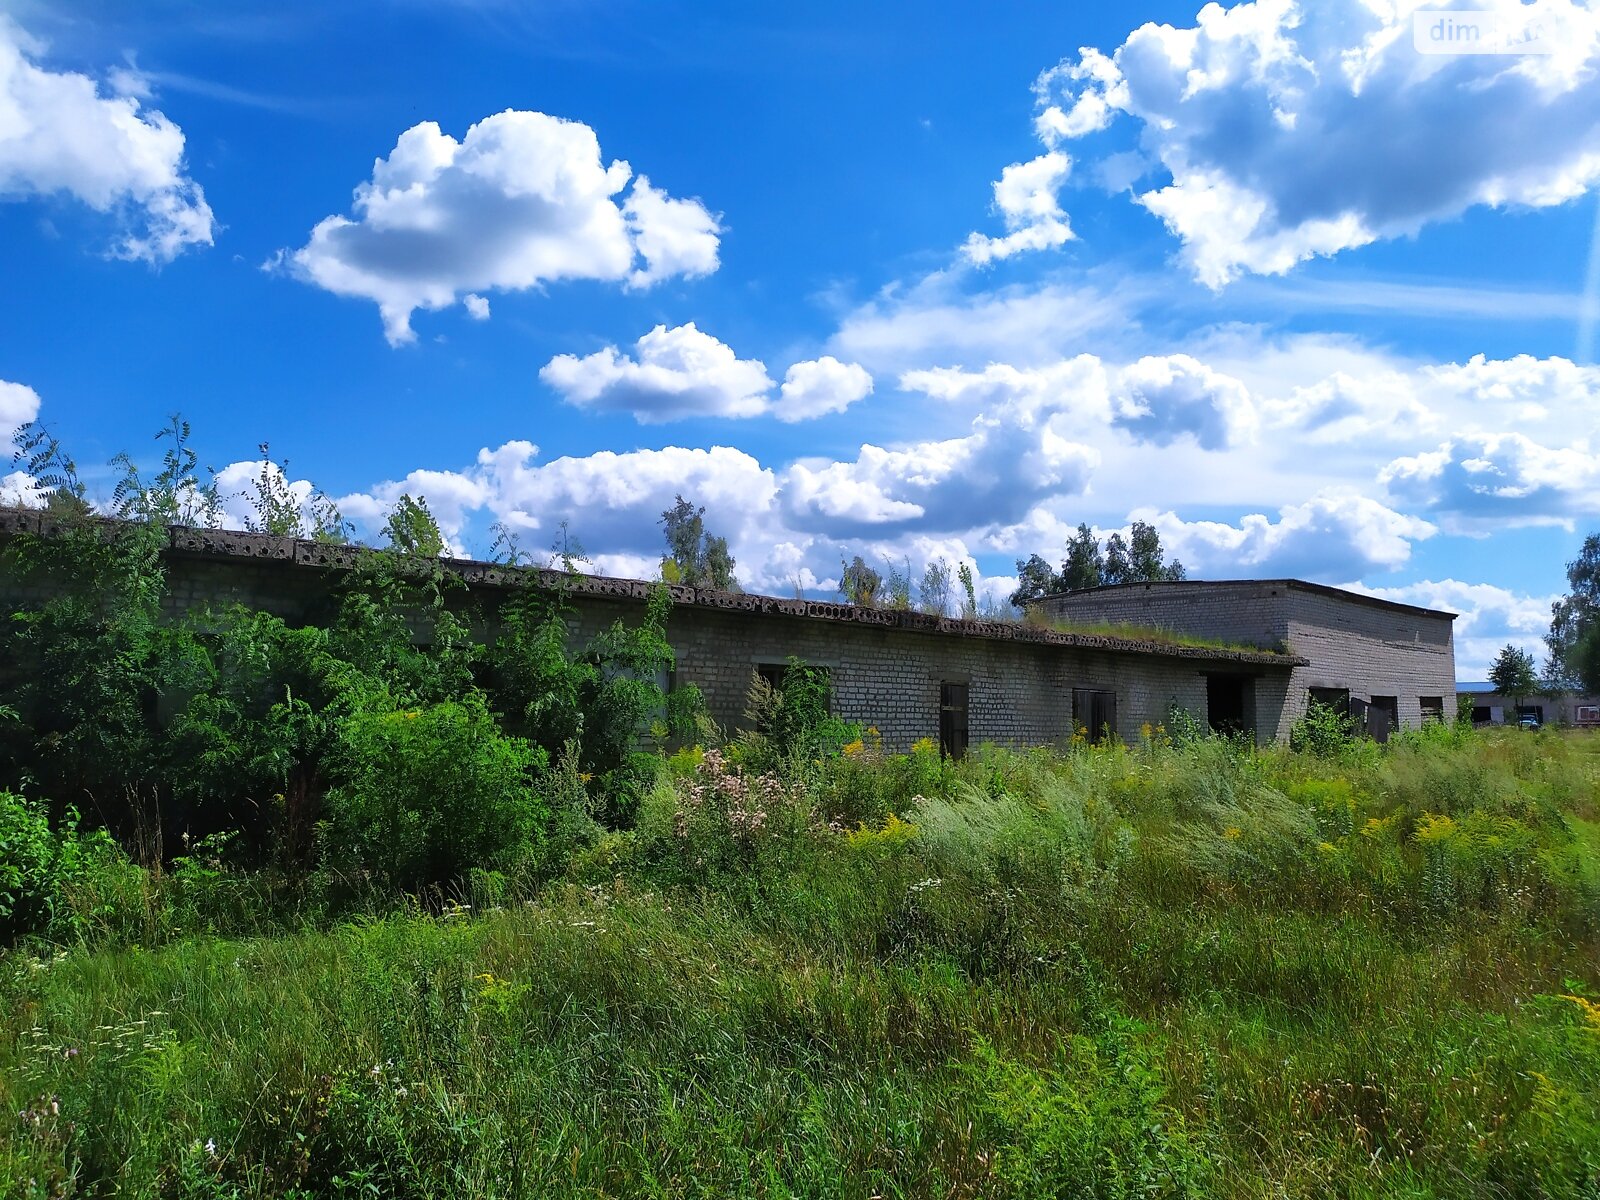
[0,14,216,262]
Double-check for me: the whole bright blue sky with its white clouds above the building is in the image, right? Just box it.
[0,0,1600,678]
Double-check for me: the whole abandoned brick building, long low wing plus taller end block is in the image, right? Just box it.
[0,509,1454,754]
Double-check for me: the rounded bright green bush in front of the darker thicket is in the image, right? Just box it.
[325,693,549,888]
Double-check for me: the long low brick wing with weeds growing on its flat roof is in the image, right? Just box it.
[0,509,1306,754]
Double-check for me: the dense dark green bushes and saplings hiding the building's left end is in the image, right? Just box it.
[0,418,699,893]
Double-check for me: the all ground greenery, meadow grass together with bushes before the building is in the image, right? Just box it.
[0,427,1600,1200]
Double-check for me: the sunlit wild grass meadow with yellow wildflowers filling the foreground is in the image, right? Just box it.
[0,726,1600,1198]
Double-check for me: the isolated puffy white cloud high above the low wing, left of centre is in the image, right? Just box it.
[281,109,720,346]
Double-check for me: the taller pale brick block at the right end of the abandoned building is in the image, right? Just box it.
[1038,579,1456,741]
